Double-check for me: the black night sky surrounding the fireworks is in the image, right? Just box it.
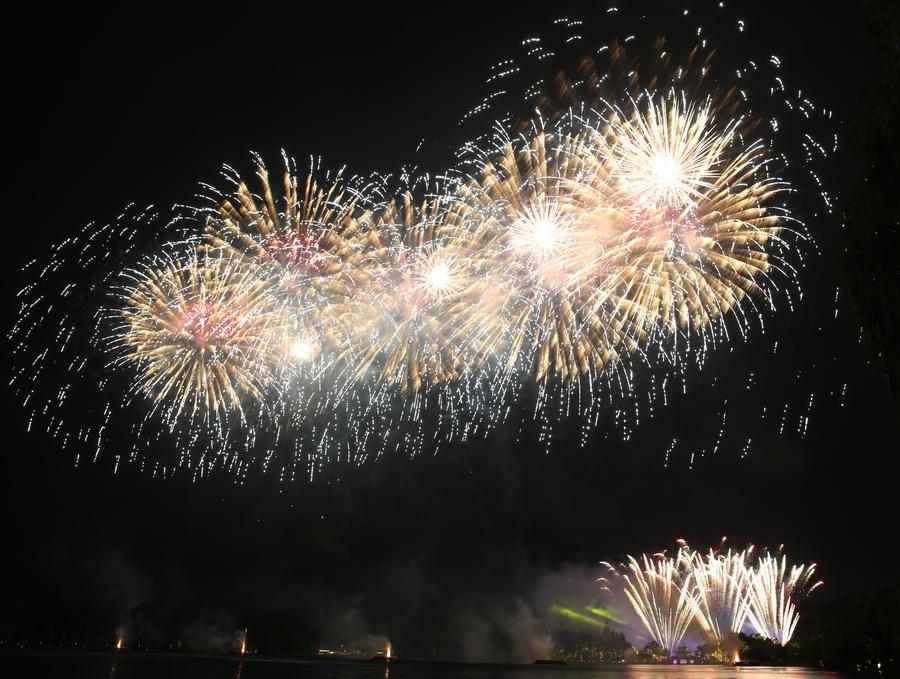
[0,2,898,658]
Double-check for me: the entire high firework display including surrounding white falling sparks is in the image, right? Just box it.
[12,2,836,476]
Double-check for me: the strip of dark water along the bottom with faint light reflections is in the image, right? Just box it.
[0,653,841,679]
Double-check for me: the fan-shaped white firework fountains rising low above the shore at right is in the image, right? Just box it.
[601,540,822,661]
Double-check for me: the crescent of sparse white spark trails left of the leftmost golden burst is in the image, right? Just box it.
[10,205,181,472]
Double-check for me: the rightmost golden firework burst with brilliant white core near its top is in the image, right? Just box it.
[582,98,785,350]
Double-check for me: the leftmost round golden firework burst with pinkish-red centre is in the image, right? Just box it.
[110,253,284,430]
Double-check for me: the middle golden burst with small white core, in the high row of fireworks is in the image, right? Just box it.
[344,193,506,394]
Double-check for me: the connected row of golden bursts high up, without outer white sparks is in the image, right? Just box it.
[146,98,783,422]
